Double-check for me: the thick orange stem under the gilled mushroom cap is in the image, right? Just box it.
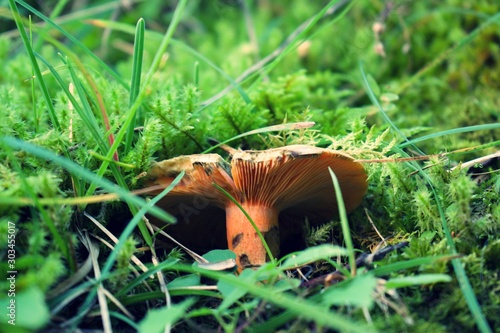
[226,203,280,271]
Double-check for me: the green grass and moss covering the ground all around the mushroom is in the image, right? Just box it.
[0,0,500,332]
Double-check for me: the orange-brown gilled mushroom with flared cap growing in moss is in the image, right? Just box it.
[148,145,368,271]
